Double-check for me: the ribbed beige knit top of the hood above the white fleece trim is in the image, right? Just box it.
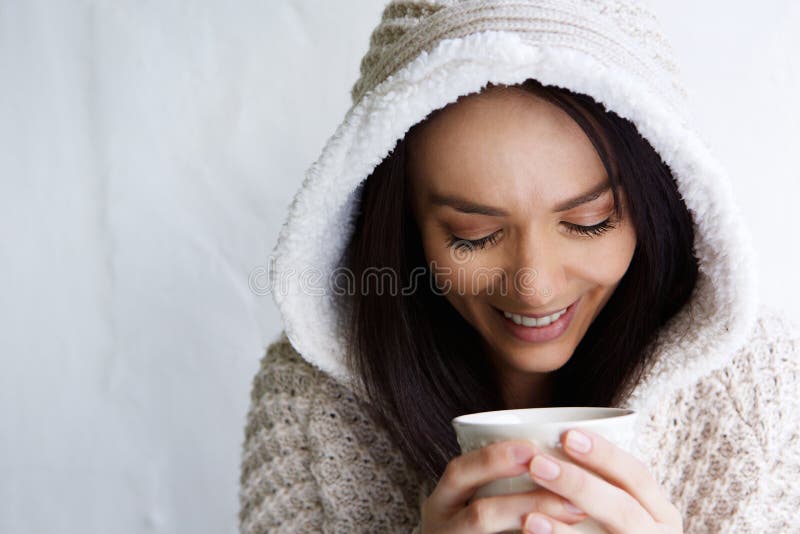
[350,0,686,111]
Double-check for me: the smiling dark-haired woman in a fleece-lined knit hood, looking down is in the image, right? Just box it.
[240,0,800,533]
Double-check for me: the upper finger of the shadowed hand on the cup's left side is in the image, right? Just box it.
[429,440,536,510]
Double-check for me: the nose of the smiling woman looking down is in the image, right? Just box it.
[508,232,566,310]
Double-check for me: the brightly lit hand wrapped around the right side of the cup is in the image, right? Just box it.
[523,429,683,534]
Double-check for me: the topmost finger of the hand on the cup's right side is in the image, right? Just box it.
[561,428,680,524]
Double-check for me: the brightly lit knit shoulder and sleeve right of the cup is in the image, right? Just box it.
[651,306,800,532]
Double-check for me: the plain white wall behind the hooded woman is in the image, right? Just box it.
[0,0,800,534]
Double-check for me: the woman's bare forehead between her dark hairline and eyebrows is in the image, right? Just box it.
[408,88,605,205]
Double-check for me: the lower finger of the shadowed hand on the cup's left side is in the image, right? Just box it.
[453,488,588,532]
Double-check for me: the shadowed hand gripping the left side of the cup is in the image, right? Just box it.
[421,440,588,534]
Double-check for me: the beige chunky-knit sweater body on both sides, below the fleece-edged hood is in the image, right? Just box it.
[239,311,800,534]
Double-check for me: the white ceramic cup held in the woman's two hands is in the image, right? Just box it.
[452,407,637,534]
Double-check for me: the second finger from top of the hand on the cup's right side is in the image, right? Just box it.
[531,454,655,532]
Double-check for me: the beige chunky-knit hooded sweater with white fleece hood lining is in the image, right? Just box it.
[240,0,800,534]
